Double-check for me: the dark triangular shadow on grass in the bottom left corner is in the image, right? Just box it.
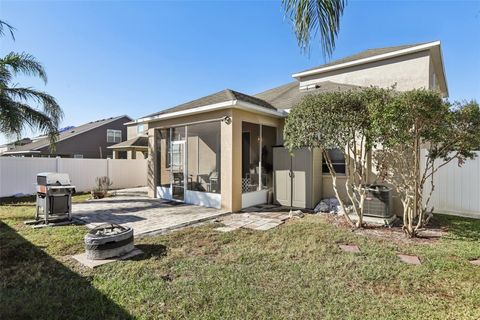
[0,221,133,319]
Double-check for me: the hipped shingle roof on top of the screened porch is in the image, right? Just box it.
[144,89,275,118]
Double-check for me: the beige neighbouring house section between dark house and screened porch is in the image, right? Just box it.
[108,123,148,159]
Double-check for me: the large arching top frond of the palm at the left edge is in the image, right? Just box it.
[0,52,47,83]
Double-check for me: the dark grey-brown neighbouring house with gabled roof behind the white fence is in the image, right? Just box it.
[2,115,132,159]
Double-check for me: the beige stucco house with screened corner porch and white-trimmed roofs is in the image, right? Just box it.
[127,41,448,211]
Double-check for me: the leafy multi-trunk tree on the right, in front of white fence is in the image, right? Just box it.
[369,89,480,236]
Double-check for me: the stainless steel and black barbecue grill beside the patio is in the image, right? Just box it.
[35,172,75,224]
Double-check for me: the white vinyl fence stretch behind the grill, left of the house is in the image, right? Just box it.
[0,157,147,197]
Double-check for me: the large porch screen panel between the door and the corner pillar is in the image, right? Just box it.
[187,122,221,193]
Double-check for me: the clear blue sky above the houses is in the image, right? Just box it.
[0,0,480,144]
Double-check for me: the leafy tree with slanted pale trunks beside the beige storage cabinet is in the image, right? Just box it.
[284,90,375,227]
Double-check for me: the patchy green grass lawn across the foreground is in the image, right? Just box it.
[0,196,480,319]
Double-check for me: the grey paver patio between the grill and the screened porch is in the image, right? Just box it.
[72,188,227,236]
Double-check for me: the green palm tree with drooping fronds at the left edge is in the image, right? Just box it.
[0,20,63,146]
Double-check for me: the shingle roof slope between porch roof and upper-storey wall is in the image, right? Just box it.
[255,81,359,109]
